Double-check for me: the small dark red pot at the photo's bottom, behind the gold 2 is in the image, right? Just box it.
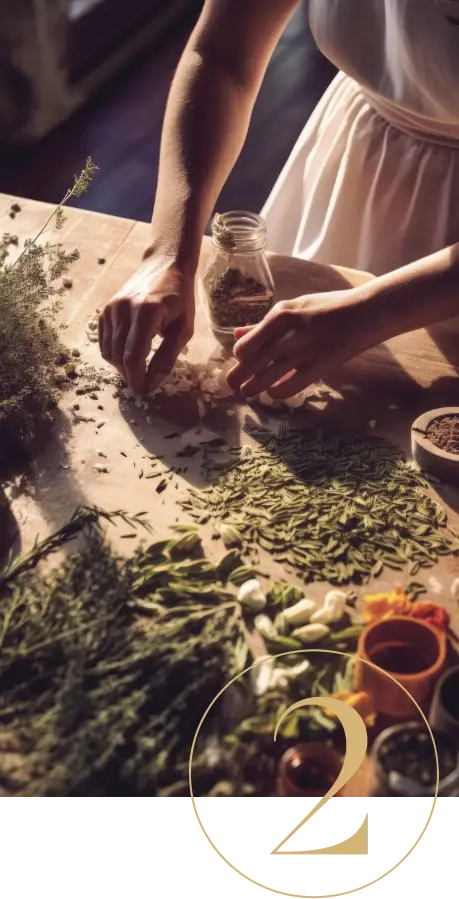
[277,743,343,799]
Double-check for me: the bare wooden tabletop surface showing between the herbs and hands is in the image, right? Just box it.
[0,195,459,795]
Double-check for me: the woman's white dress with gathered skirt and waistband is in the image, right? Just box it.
[262,0,459,274]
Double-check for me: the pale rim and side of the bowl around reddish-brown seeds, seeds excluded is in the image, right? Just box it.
[411,406,459,485]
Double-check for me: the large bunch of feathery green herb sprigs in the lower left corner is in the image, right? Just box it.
[0,509,247,798]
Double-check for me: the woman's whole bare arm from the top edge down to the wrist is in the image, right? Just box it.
[146,0,298,270]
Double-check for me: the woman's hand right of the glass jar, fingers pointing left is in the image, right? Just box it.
[228,289,379,399]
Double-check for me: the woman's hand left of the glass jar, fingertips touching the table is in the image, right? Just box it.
[99,255,195,393]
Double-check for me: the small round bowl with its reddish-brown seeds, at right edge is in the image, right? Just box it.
[411,406,459,485]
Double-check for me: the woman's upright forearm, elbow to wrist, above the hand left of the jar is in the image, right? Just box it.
[148,49,253,269]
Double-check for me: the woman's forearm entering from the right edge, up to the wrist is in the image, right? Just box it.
[359,244,459,343]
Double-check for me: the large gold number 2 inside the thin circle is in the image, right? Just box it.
[267,696,368,858]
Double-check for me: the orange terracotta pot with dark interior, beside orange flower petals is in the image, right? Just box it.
[355,615,447,718]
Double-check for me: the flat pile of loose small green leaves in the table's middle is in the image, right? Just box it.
[183,427,459,584]
